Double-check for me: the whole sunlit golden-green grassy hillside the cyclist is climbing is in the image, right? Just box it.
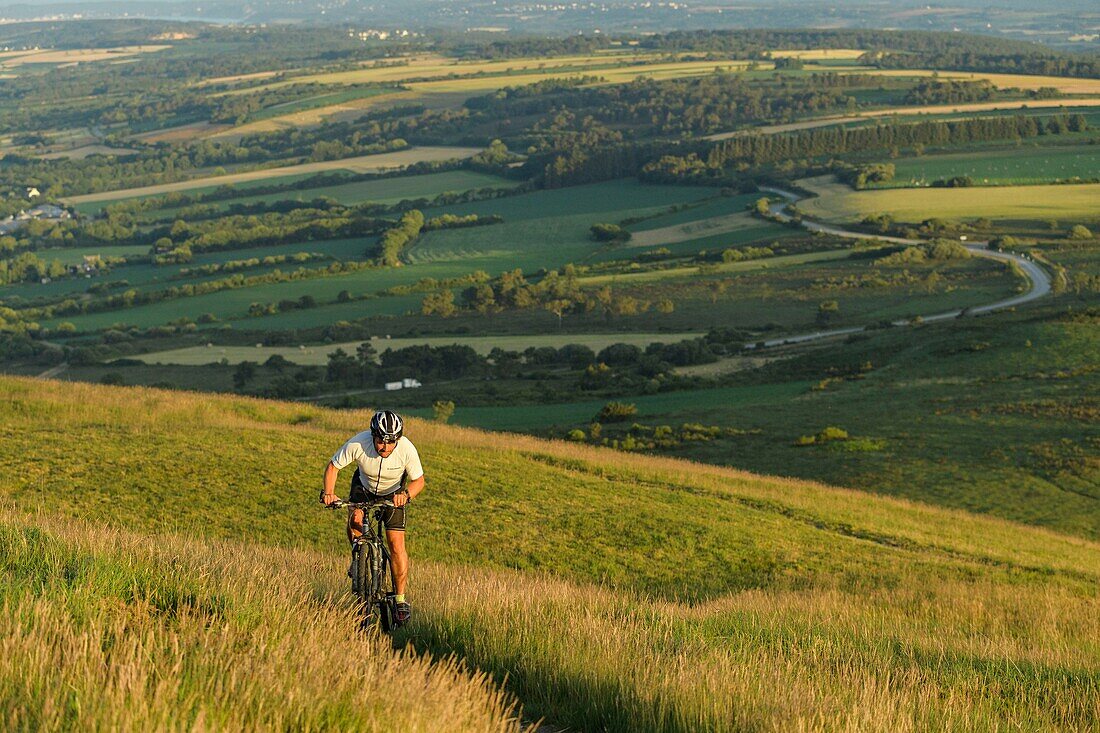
[0,378,1100,731]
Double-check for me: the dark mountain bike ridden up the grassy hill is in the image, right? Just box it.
[329,499,400,634]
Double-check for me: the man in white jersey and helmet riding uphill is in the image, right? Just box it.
[321,409,424,624]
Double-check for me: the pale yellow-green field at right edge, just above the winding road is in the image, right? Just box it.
[799,176,1100,222]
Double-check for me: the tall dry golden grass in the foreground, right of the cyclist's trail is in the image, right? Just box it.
[414,567,1100,733]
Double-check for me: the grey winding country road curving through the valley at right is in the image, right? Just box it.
[745,186,1051,349]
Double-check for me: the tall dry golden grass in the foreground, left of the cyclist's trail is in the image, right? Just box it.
[0,511,524,733]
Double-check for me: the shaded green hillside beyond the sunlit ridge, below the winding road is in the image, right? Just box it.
[433,301,1100,539]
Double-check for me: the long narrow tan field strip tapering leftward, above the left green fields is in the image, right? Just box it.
[65,145,481,205]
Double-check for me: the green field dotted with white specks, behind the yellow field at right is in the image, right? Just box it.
[875,145,1100,188]
